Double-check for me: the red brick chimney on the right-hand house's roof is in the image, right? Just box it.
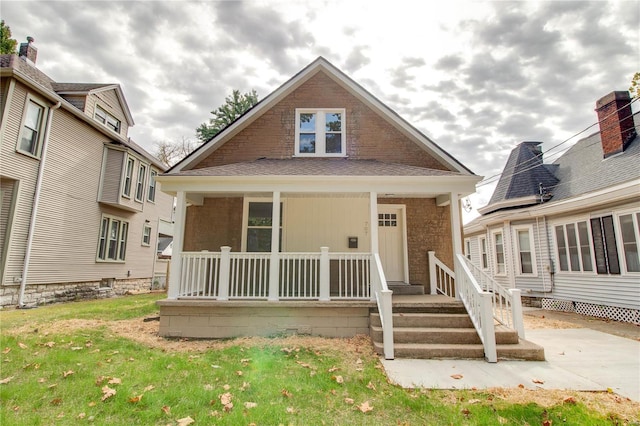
[596,92,636,158]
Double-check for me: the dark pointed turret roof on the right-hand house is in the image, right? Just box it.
[488,142,558,206]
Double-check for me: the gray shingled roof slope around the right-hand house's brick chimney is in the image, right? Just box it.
[551,130,640,201]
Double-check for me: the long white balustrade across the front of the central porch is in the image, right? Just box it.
[177,247,372,300]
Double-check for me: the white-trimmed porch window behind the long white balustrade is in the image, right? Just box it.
[245,201,283,252]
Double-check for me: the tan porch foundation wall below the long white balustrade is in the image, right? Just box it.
[158,300,373,338]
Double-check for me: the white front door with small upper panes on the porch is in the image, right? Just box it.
[378,204,405,282]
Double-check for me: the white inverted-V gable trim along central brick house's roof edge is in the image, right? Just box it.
[168,56,473,175]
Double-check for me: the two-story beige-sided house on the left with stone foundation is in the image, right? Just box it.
[0,43,173,306]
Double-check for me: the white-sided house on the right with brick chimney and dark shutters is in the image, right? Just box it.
[464,92,640,324]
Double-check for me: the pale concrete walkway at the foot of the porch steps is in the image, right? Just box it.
[382,312,640,401]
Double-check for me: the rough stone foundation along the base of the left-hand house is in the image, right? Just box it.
[0,277,151,307]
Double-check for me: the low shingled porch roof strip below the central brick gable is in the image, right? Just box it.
[171,158,463,176]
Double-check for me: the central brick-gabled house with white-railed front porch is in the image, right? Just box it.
[158,58,480,337]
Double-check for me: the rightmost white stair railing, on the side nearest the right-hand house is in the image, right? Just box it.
[462,257,524,339]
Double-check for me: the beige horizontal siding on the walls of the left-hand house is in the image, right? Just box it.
[0,80,173,285]
